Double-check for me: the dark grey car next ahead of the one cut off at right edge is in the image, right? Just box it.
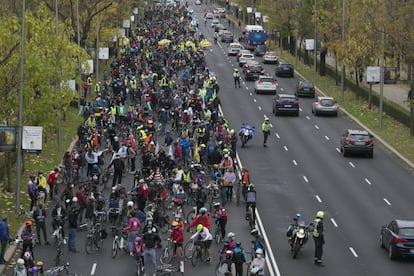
[340,129,374,158]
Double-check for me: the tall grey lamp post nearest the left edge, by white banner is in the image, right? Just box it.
[15,0,26,214]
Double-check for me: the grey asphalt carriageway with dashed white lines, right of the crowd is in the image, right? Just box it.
[202,10,412,275]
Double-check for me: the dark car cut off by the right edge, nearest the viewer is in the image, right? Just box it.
[380,219,414,260]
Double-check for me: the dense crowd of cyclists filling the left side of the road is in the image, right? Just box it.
[12,4,265,275]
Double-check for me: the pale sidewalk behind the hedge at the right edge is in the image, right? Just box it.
[326,55,410,111]
